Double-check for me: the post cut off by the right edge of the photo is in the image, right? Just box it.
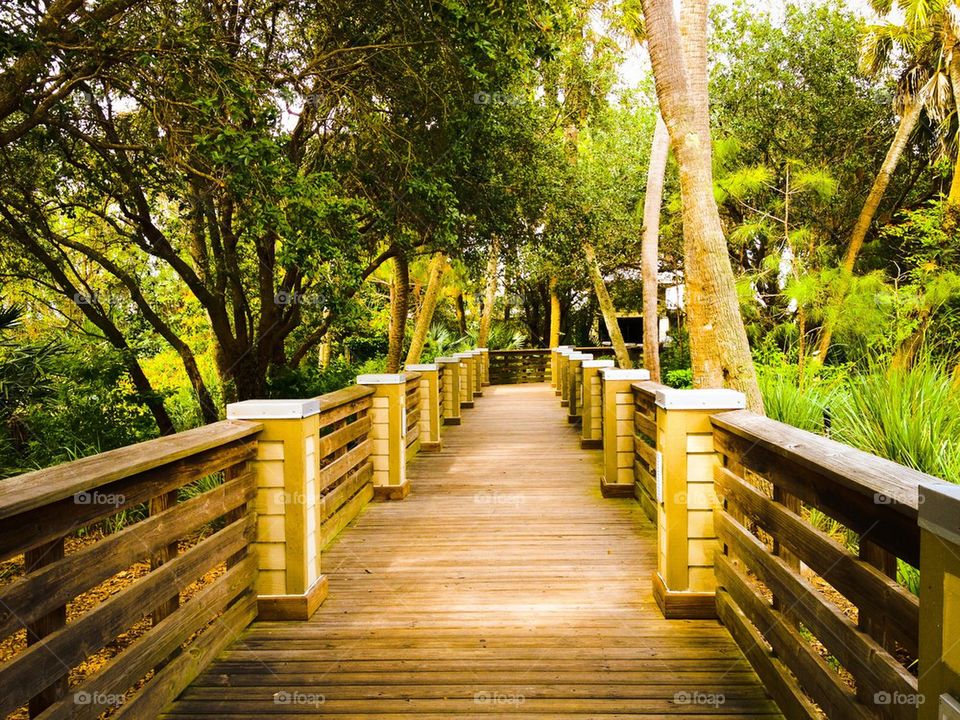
[917,483,960,720]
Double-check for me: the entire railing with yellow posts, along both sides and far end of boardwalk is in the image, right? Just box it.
[0,348,960,720]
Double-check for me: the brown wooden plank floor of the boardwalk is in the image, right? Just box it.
[169,385,780,720]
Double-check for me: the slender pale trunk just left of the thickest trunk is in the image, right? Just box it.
[640,113,670,382]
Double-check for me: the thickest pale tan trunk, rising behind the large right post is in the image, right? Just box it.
[643,0,763,412]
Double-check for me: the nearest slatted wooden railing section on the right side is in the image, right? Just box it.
[713,411,937,719]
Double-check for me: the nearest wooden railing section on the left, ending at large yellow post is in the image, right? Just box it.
[0,421,260,720]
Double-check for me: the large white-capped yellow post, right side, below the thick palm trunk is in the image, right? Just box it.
[653,388,746,618]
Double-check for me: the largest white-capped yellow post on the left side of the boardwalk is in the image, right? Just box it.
[227,398,327,620]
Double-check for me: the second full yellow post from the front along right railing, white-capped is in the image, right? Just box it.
[599,367,650,498]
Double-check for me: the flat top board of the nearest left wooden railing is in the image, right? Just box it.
[0,420,263,519]
